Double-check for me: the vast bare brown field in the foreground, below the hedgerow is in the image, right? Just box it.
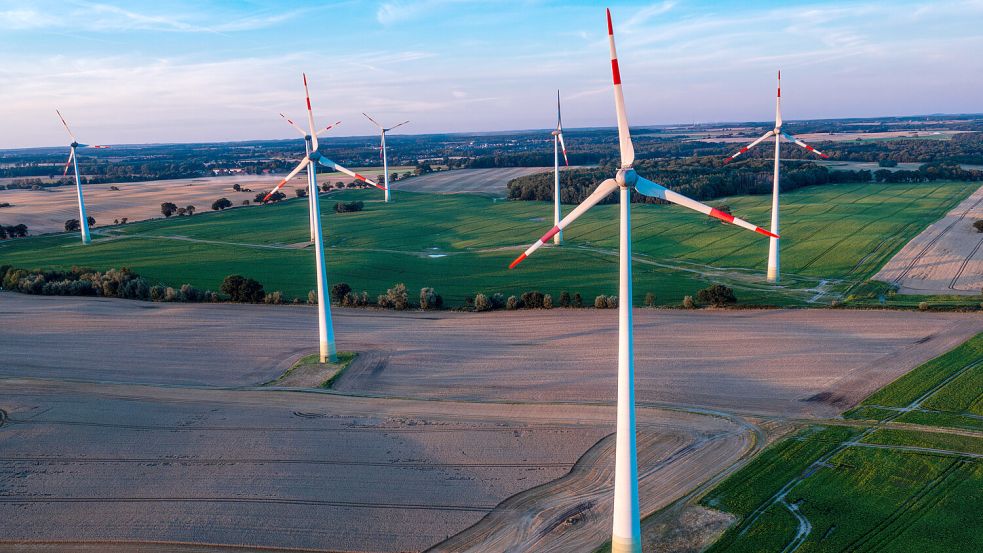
[0,293,983,552]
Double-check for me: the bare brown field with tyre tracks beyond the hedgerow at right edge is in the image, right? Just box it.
[874,183,983,295]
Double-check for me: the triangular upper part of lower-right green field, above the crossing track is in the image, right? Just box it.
[846,334,983,430]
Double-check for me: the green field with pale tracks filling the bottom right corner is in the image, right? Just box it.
[702,335,983,553]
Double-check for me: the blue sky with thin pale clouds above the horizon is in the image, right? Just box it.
[0,0,983,148]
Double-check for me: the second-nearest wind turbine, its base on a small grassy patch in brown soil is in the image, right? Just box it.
[263,73,382,363]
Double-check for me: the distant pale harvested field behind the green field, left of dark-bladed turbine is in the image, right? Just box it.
[391,167,553,198]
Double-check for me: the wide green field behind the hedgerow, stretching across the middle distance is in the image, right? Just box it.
[0,183,975,306]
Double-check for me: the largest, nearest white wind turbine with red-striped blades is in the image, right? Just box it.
[509,10,774,553]
